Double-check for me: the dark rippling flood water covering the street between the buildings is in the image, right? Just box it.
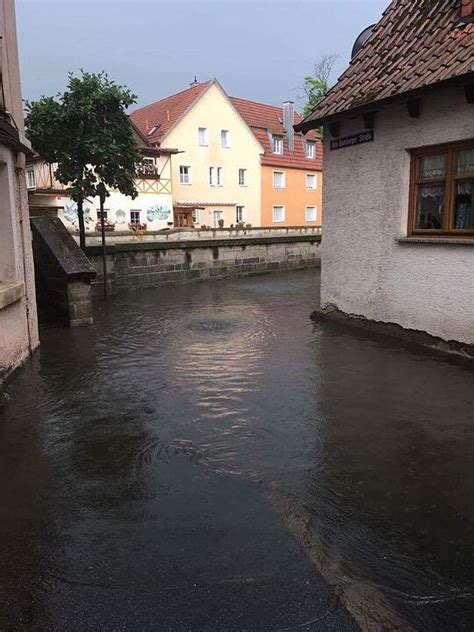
[0,271,474,632]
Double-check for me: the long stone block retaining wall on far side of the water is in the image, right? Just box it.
[86,235,321,297]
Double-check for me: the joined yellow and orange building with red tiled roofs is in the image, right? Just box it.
[131,79,322,228]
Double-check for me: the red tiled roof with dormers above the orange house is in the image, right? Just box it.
[231,97,323,171]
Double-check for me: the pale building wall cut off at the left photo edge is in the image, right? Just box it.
[0,0,39,380]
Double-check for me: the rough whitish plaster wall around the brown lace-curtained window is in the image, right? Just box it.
[321,88,474,344]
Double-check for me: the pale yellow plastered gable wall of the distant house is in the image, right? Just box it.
[162,84,263,227]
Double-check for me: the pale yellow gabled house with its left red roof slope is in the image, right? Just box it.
[131,80,263,228]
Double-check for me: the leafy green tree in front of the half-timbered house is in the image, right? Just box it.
[25,71,142,249]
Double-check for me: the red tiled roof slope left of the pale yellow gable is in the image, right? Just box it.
[130,80,212,143]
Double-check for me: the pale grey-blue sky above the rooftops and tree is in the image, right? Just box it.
[17,0,389,110]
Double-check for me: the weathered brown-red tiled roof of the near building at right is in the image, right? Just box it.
[300,0,474,129]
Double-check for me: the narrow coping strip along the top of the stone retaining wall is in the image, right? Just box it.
[86,235,321,256]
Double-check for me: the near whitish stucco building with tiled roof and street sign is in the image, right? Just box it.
[299,0,474,354]
